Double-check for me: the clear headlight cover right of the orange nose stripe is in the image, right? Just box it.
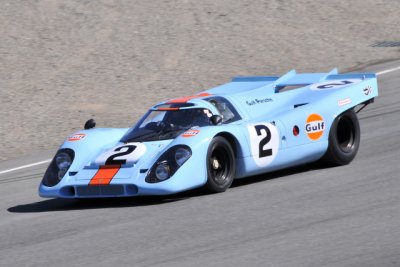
[145,145,192,183]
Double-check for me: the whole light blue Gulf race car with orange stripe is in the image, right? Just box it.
[39,69,378,198]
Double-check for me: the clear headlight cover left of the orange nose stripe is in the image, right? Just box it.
[42,148,75,187]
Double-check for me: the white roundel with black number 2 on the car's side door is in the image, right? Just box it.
[247,123,279,167]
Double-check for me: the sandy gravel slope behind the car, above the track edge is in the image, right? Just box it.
[0,0,400,160]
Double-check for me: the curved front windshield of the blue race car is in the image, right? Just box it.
[121,108,212,143]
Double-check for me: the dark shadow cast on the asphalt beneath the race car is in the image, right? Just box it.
[7,165,318,213]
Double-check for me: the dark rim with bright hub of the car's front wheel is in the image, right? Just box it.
[209,146,230,185]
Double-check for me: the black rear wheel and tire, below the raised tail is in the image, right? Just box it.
[319,109,360,166]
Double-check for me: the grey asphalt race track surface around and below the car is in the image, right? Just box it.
[0,61,400,266]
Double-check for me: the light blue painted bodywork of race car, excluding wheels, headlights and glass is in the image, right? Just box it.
[39,69,378,198]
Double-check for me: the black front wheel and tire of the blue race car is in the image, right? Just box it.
[205,136,236,193]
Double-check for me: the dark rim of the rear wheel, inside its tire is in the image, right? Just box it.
[336,117,356,153]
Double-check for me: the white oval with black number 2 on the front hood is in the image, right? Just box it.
[95,143,146,165]
